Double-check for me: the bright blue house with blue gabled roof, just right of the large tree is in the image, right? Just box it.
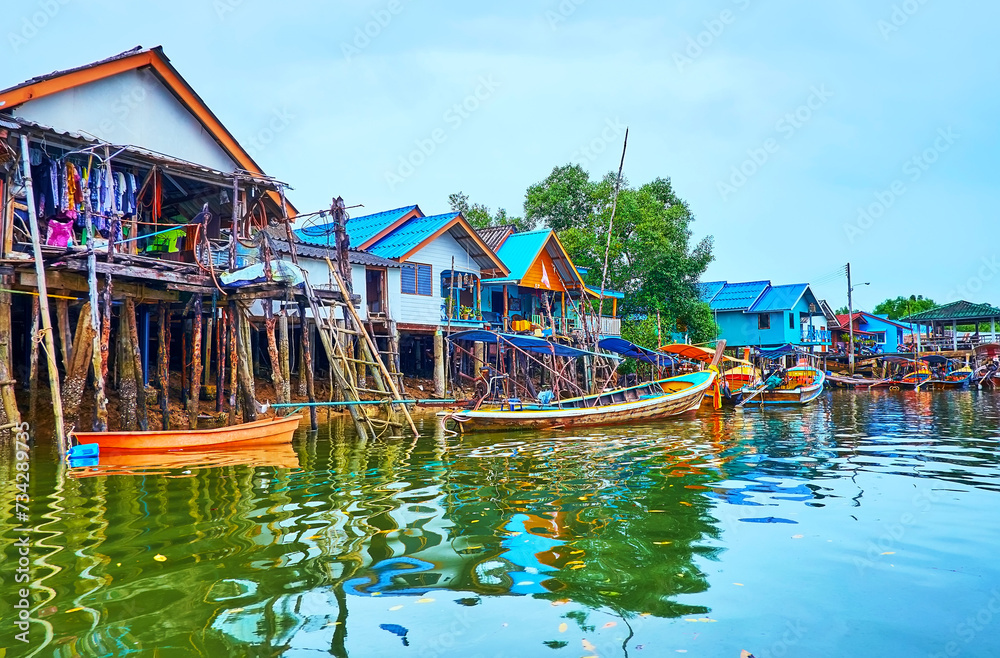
[700,281,830,352]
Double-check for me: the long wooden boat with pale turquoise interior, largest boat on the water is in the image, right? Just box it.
[445,370,716,431]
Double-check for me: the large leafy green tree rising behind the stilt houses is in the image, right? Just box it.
[524,165,716,340]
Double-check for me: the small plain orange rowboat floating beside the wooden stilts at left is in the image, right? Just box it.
[73,414,302,453]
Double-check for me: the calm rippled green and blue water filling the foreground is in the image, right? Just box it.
[0,391,1000,658]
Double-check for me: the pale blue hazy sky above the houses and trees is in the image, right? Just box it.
[0,0,1000,306]
